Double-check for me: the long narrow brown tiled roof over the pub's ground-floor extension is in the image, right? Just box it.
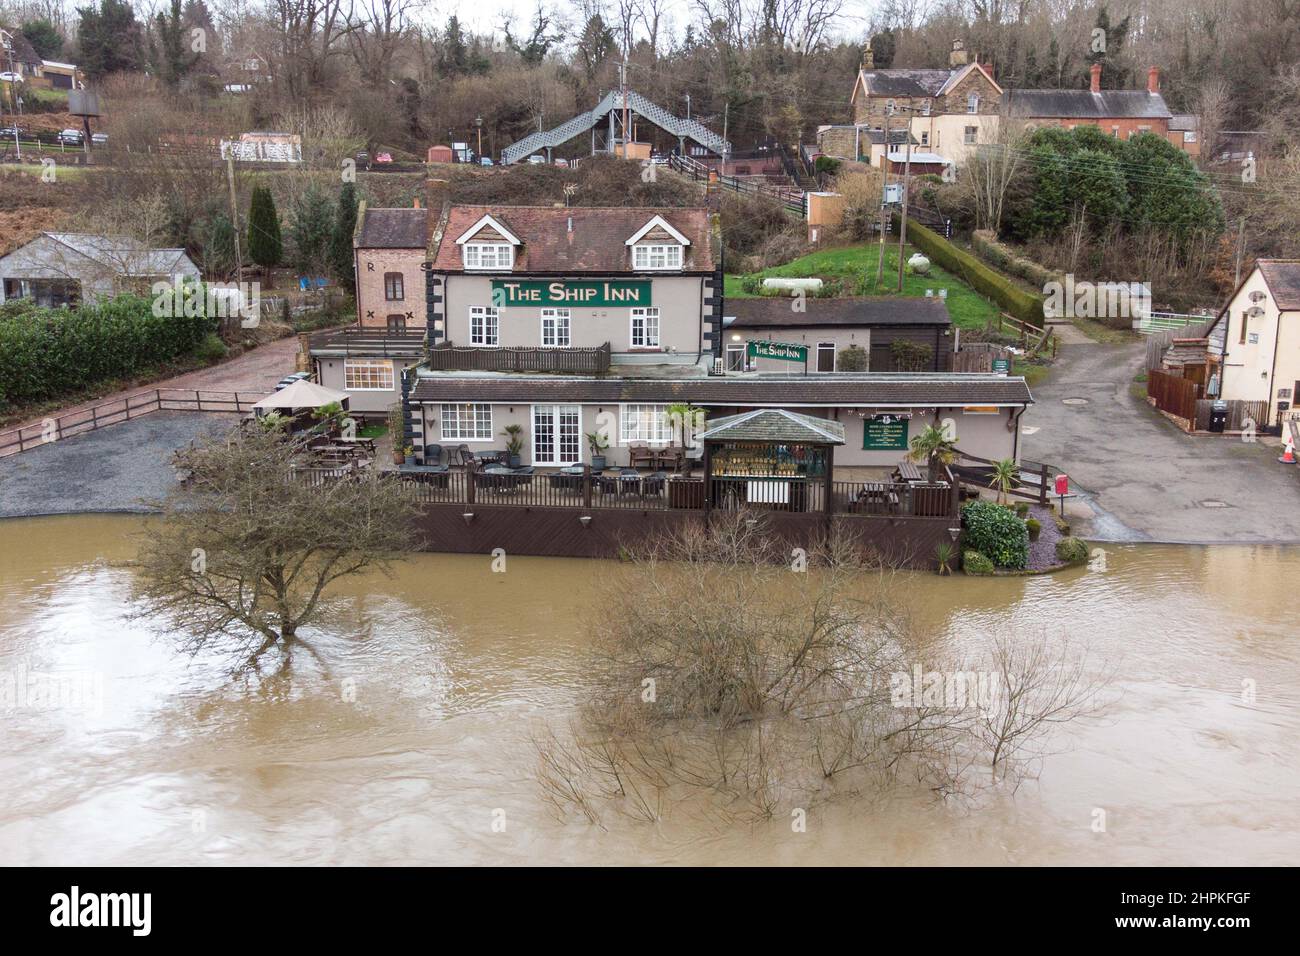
[412,372,1034,407]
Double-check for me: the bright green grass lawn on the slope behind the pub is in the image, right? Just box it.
[725,243,998,329]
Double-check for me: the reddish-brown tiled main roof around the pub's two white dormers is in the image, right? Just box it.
[433,206,714,273]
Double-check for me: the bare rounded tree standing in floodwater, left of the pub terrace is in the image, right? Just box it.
[134,425,419,670]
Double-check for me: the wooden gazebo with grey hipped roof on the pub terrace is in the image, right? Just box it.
[699,408,844,511]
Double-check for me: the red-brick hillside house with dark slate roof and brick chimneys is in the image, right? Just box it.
[1004,64,1195,150]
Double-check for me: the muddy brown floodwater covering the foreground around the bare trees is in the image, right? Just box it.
[0,516,1300,865]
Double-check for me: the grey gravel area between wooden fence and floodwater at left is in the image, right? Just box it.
[0,411,238,518]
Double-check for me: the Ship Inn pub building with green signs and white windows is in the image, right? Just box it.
[311,181,1034,480]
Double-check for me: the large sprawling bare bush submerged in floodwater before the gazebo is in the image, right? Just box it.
[534,512,1100,825]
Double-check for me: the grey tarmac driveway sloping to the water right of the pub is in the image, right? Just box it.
[1021,342,1300,544]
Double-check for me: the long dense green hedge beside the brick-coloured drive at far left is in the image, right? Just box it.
[0,295,217,408]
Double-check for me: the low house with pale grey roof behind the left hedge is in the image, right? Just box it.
[0,233,199,307]
